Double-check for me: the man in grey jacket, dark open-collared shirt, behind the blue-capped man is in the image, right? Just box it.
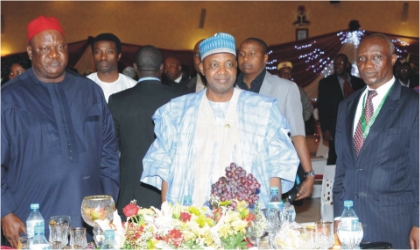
[236,38,315,200]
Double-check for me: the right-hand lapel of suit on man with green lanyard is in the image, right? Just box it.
[359,81,401,156]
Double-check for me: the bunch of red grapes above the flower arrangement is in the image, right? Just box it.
[211,162,261,209]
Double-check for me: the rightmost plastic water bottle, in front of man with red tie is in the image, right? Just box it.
[337,200,363,249]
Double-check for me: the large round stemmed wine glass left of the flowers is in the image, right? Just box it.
[81,195,115,246]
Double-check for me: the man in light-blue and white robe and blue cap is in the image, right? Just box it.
[141,33,299,206]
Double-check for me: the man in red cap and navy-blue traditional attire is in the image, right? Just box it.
[1,16,119,248]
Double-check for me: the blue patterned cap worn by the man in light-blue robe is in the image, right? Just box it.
[199,32,236,60]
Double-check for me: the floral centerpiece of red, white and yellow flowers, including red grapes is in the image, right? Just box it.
[113,163,265,249]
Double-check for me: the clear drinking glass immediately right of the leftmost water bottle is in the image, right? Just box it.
[49,215,71,248]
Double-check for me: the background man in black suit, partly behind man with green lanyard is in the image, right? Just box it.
[318,54,365,165]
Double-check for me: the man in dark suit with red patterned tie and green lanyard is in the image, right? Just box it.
[333,34,419,249]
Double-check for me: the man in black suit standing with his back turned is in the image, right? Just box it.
[108,45,177,216]
